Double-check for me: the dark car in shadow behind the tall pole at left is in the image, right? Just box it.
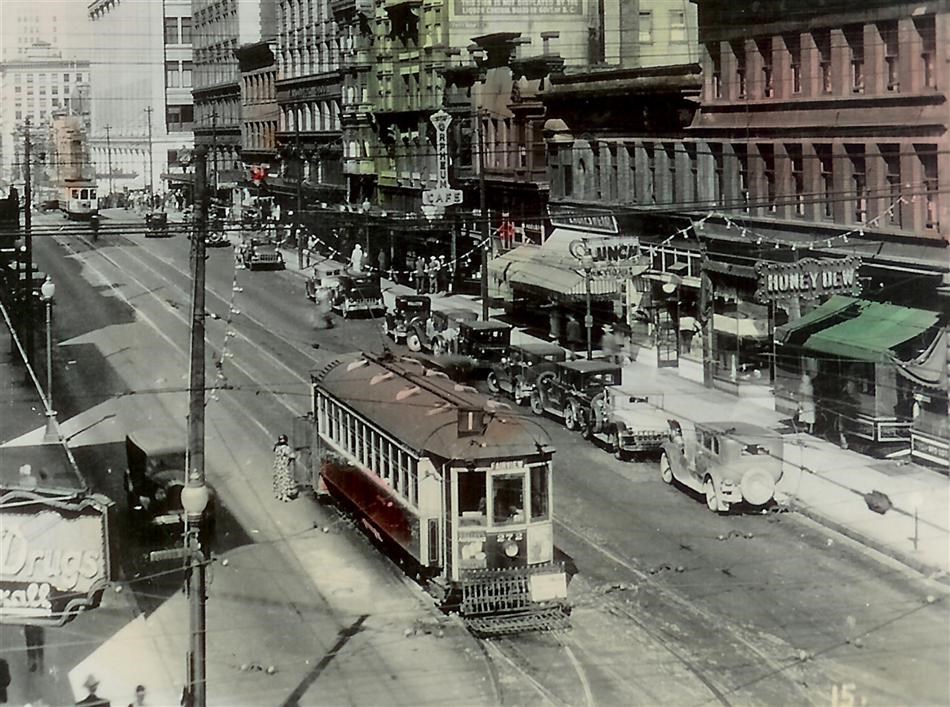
[125,427,215,544]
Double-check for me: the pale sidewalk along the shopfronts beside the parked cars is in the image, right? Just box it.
[278,246,950,582]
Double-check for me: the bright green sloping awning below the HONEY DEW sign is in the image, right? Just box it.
[804,300,939,362]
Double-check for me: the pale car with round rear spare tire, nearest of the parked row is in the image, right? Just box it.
[660,420,782,513]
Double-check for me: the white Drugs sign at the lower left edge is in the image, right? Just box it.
[0,496,111,626]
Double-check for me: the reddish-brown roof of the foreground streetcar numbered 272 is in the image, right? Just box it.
[312,353,551,461]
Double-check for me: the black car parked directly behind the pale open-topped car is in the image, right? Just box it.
[531,361,621,430]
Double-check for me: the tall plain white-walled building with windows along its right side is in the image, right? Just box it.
[88,0,194,196]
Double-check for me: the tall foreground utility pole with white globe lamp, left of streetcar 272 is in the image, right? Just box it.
[182,146,209,707]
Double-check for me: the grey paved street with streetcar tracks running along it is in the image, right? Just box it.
[3,214,950,705]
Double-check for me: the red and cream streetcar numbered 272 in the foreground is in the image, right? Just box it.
[311,353,569,635]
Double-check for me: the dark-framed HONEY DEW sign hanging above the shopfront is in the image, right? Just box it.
[755,257,861,302]
